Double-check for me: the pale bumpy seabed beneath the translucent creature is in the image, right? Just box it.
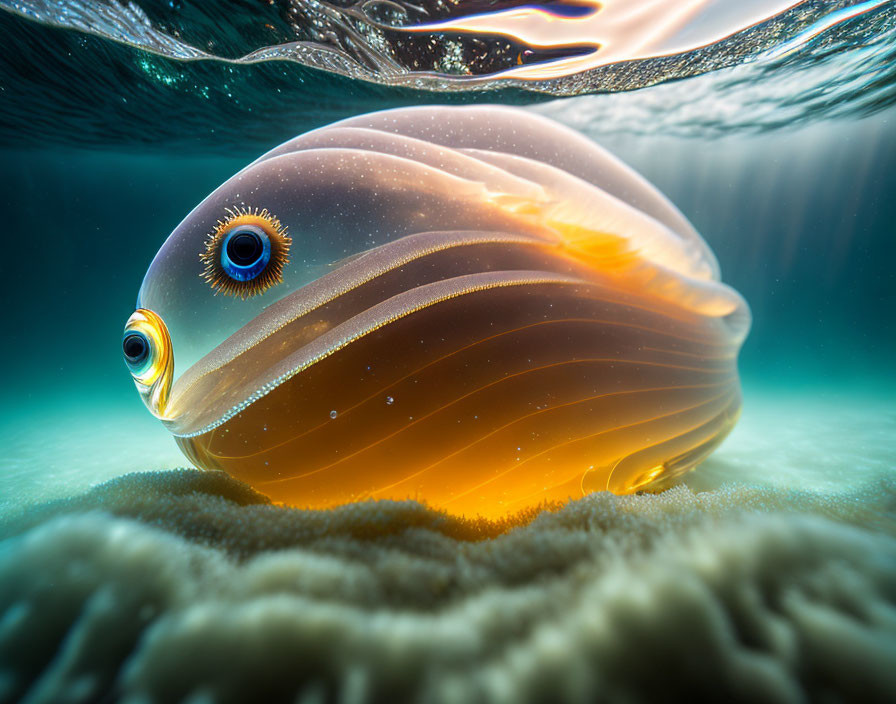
[0,388,896,702]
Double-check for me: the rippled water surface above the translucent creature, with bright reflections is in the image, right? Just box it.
[0,0,896,154]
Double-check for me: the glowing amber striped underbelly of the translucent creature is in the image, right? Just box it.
[177,283,741,518]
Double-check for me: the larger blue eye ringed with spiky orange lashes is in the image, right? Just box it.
[199,208,291,298]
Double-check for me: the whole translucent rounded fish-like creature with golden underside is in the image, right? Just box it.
[124,106,750,517]
